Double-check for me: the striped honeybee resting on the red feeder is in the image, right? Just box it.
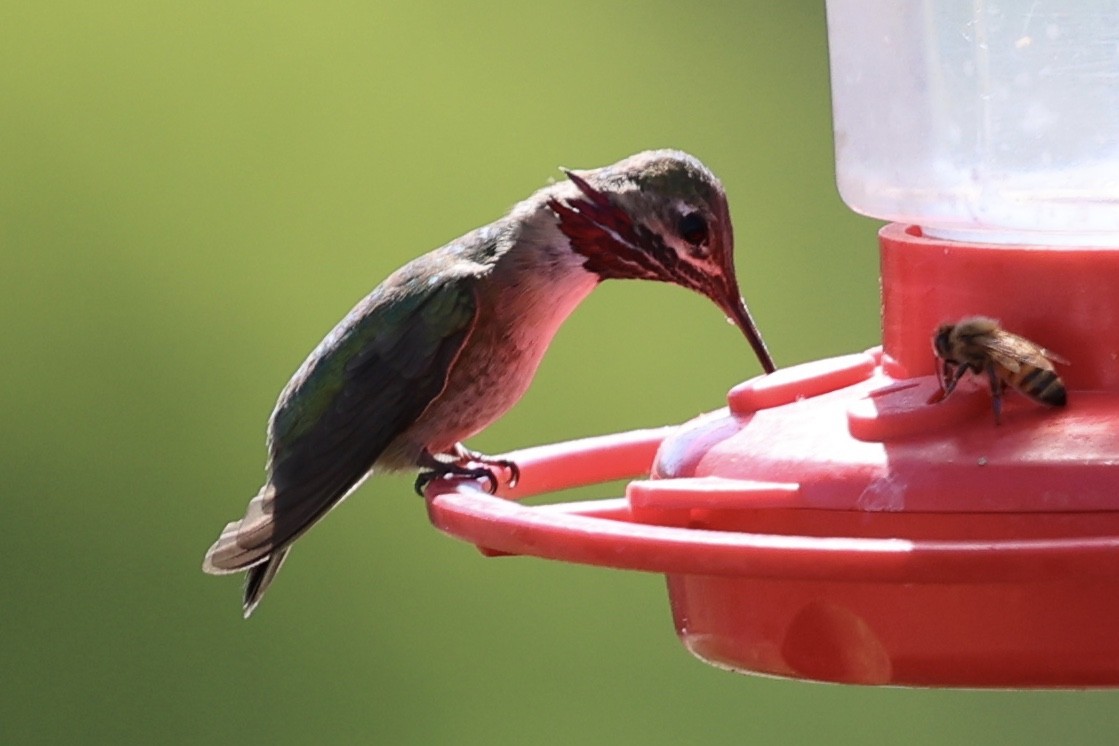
[932,317,1069,424]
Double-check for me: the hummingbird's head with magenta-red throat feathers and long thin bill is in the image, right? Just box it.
[548,150,777,372]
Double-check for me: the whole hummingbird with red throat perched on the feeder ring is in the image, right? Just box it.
[203,150,775,618]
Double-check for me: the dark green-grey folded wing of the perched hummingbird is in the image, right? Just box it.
[204,257,478,577]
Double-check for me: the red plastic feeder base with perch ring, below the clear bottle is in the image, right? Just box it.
[427,224,1119,687]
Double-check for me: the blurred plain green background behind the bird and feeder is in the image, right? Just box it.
[0,0,1119,744]
